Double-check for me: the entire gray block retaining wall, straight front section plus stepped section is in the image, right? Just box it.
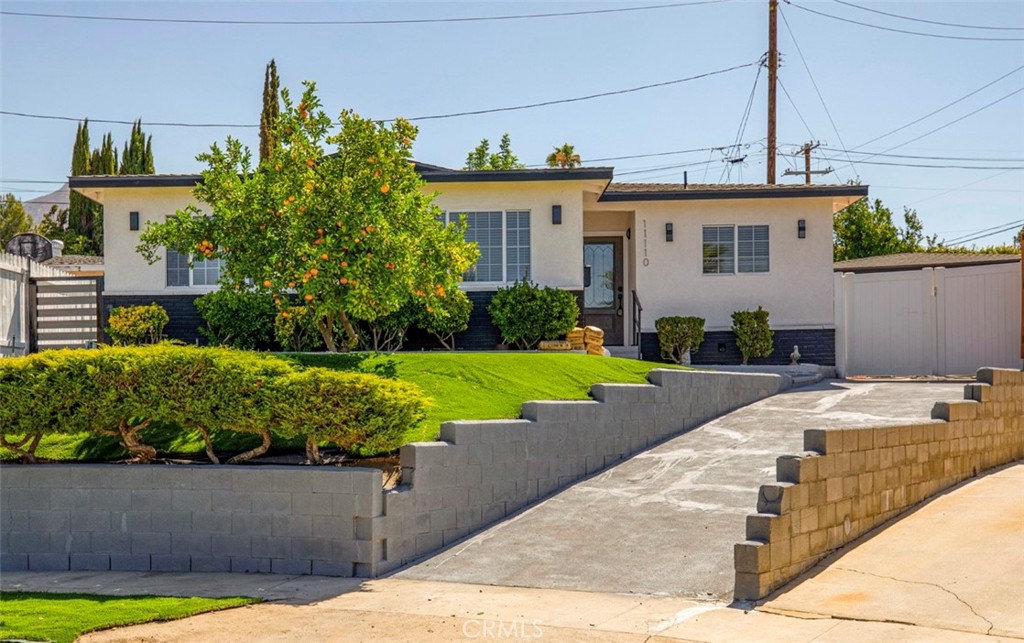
[0,370,781,577]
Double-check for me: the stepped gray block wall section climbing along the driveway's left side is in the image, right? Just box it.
[370,369,782,572]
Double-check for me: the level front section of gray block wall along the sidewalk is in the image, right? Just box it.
[0,464,383,576]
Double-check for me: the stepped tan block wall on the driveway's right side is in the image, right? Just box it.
[734,369,1024,600]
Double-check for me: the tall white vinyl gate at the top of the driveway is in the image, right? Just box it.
[836,263,1021,377]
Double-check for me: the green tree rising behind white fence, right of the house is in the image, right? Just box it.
[833,199,935,261]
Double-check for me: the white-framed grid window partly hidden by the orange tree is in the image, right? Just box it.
[444,210,530,283]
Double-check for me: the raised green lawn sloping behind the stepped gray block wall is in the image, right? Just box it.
[8,352,678,461]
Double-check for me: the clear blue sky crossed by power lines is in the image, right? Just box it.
[6,0,1024,244]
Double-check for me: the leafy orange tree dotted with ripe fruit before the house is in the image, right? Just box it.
[138,82,479,351]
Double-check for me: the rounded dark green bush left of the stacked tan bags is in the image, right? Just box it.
[487,280,580,349]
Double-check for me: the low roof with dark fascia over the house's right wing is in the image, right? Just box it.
[600,183,867,201]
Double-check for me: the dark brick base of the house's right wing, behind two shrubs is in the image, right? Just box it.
[640,329,836,367]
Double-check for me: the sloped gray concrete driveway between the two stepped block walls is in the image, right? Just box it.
[395,381,964,600]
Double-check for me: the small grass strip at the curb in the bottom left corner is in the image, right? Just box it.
[0,592,258,643]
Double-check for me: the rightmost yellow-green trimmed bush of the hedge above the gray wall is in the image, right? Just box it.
[273,369,425,464]
